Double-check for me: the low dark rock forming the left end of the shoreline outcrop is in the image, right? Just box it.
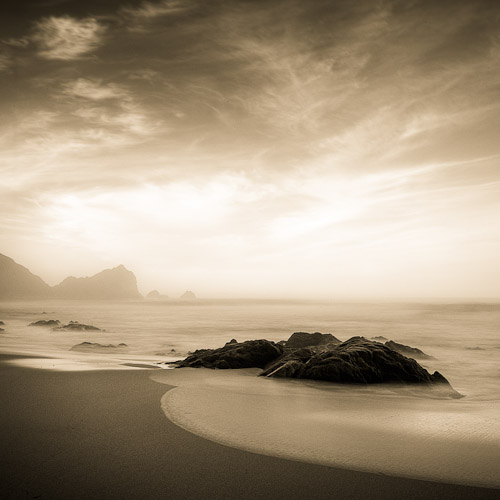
[177,340,283,369]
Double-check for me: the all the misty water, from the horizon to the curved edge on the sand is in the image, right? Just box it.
[0,301,500,487]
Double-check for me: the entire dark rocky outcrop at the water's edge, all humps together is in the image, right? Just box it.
[169,332,461,398]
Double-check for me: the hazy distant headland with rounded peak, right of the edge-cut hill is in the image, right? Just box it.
[54,266,142,300]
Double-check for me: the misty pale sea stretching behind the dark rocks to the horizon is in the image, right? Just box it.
[0,300,500,401]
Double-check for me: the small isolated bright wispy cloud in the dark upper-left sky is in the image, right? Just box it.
[31,16,105,61]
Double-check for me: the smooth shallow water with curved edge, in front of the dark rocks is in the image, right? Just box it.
[152,368,500,488]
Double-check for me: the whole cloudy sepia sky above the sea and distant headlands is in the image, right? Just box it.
[0,0,500,299]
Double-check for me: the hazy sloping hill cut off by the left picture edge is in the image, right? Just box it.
[0,254,52,300]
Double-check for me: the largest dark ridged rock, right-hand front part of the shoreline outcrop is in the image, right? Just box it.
[261,337,459,397]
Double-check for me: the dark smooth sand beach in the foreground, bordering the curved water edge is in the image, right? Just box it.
[0,355,500,500]
